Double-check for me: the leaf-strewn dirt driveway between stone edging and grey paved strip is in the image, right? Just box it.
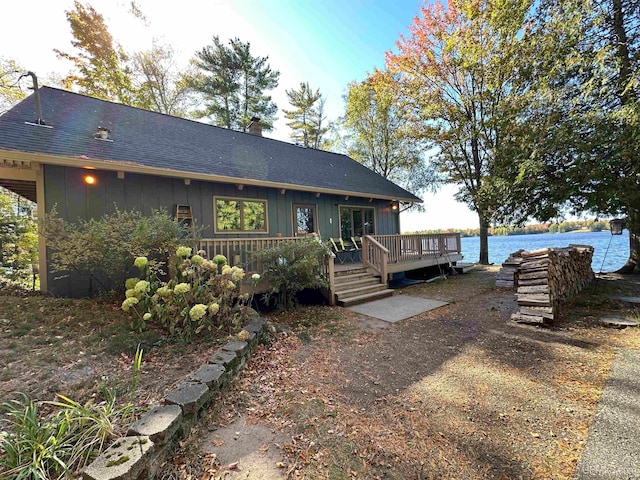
[164,267,640,480]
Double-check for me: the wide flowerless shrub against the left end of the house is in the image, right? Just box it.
[40,208,201,291]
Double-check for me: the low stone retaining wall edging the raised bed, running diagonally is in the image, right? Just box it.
[82,318,266,480]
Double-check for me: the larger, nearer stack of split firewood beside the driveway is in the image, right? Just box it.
[511,245,593,323]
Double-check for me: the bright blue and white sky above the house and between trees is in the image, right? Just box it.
[0,0,478,232]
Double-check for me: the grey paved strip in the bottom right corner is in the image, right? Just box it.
[576,350,640,480]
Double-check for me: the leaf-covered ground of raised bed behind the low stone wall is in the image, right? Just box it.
[0,291,226,416]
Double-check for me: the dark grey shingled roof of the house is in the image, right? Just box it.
[0,87,421,202]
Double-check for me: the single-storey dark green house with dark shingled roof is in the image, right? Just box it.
[0,87,459,296]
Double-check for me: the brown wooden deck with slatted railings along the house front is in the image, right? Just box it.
[197,233,462,305]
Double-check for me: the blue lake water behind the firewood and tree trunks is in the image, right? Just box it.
[461,230,629,272]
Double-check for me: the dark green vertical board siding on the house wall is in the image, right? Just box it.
[44,165,399,297]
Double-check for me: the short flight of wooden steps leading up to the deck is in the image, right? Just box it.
[335,268,393,307]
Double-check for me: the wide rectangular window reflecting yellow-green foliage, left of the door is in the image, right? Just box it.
[214,198,267,233]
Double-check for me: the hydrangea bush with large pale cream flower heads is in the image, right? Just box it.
[122,247,259,339]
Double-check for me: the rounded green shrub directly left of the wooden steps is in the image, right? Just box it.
[254,238,329,310]
